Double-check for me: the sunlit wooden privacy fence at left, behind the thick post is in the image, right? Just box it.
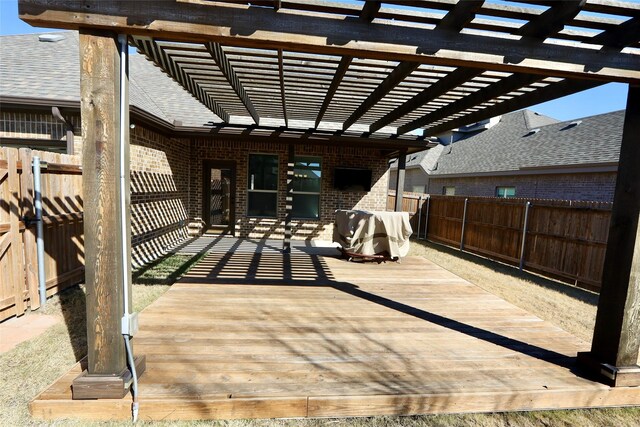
[0,147,84,321]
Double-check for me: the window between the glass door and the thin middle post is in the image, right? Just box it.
[247,154,278,218]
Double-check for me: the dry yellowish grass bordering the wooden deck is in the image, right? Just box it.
[0,246,640,427]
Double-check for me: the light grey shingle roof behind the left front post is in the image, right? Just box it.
[0,31,219,127]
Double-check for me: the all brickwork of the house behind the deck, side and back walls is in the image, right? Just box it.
[0,111,396,260]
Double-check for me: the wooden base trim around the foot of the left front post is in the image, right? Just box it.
[71,356,146,400]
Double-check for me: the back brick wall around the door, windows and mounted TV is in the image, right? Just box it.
[189,139,388,240]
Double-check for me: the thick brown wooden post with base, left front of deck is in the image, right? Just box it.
[73,30,143,399]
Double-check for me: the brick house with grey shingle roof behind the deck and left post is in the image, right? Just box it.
[0,32,408,265]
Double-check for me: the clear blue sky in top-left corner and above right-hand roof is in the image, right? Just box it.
[0,0,627,121]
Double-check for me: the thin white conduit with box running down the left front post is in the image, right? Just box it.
[118,34,139,422]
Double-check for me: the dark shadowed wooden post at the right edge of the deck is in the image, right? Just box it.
[578,86,640,386]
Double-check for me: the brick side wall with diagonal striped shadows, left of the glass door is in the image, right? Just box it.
[130,125,190,266]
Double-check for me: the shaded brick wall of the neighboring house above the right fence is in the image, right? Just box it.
[428,172,616,202]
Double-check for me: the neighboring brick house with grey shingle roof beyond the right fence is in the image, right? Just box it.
[390,110,624,202]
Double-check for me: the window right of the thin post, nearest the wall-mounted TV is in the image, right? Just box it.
[291,156,322,219]
